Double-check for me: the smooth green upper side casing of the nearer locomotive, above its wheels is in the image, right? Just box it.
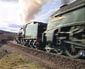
[47,0,85,30]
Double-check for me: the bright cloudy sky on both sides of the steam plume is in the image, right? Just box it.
[0,0,75,32]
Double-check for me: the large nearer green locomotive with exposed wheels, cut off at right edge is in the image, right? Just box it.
[44,0,85,58]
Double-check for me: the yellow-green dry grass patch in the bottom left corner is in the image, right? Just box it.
[0,54,45,69]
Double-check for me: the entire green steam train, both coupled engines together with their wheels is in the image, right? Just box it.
[15,0,85,58]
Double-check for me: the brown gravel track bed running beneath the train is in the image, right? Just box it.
[1,42,85,69]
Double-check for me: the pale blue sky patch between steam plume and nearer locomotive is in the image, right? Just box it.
[35,0,61,22]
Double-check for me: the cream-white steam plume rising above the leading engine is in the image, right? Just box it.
[19,0,48,23]
